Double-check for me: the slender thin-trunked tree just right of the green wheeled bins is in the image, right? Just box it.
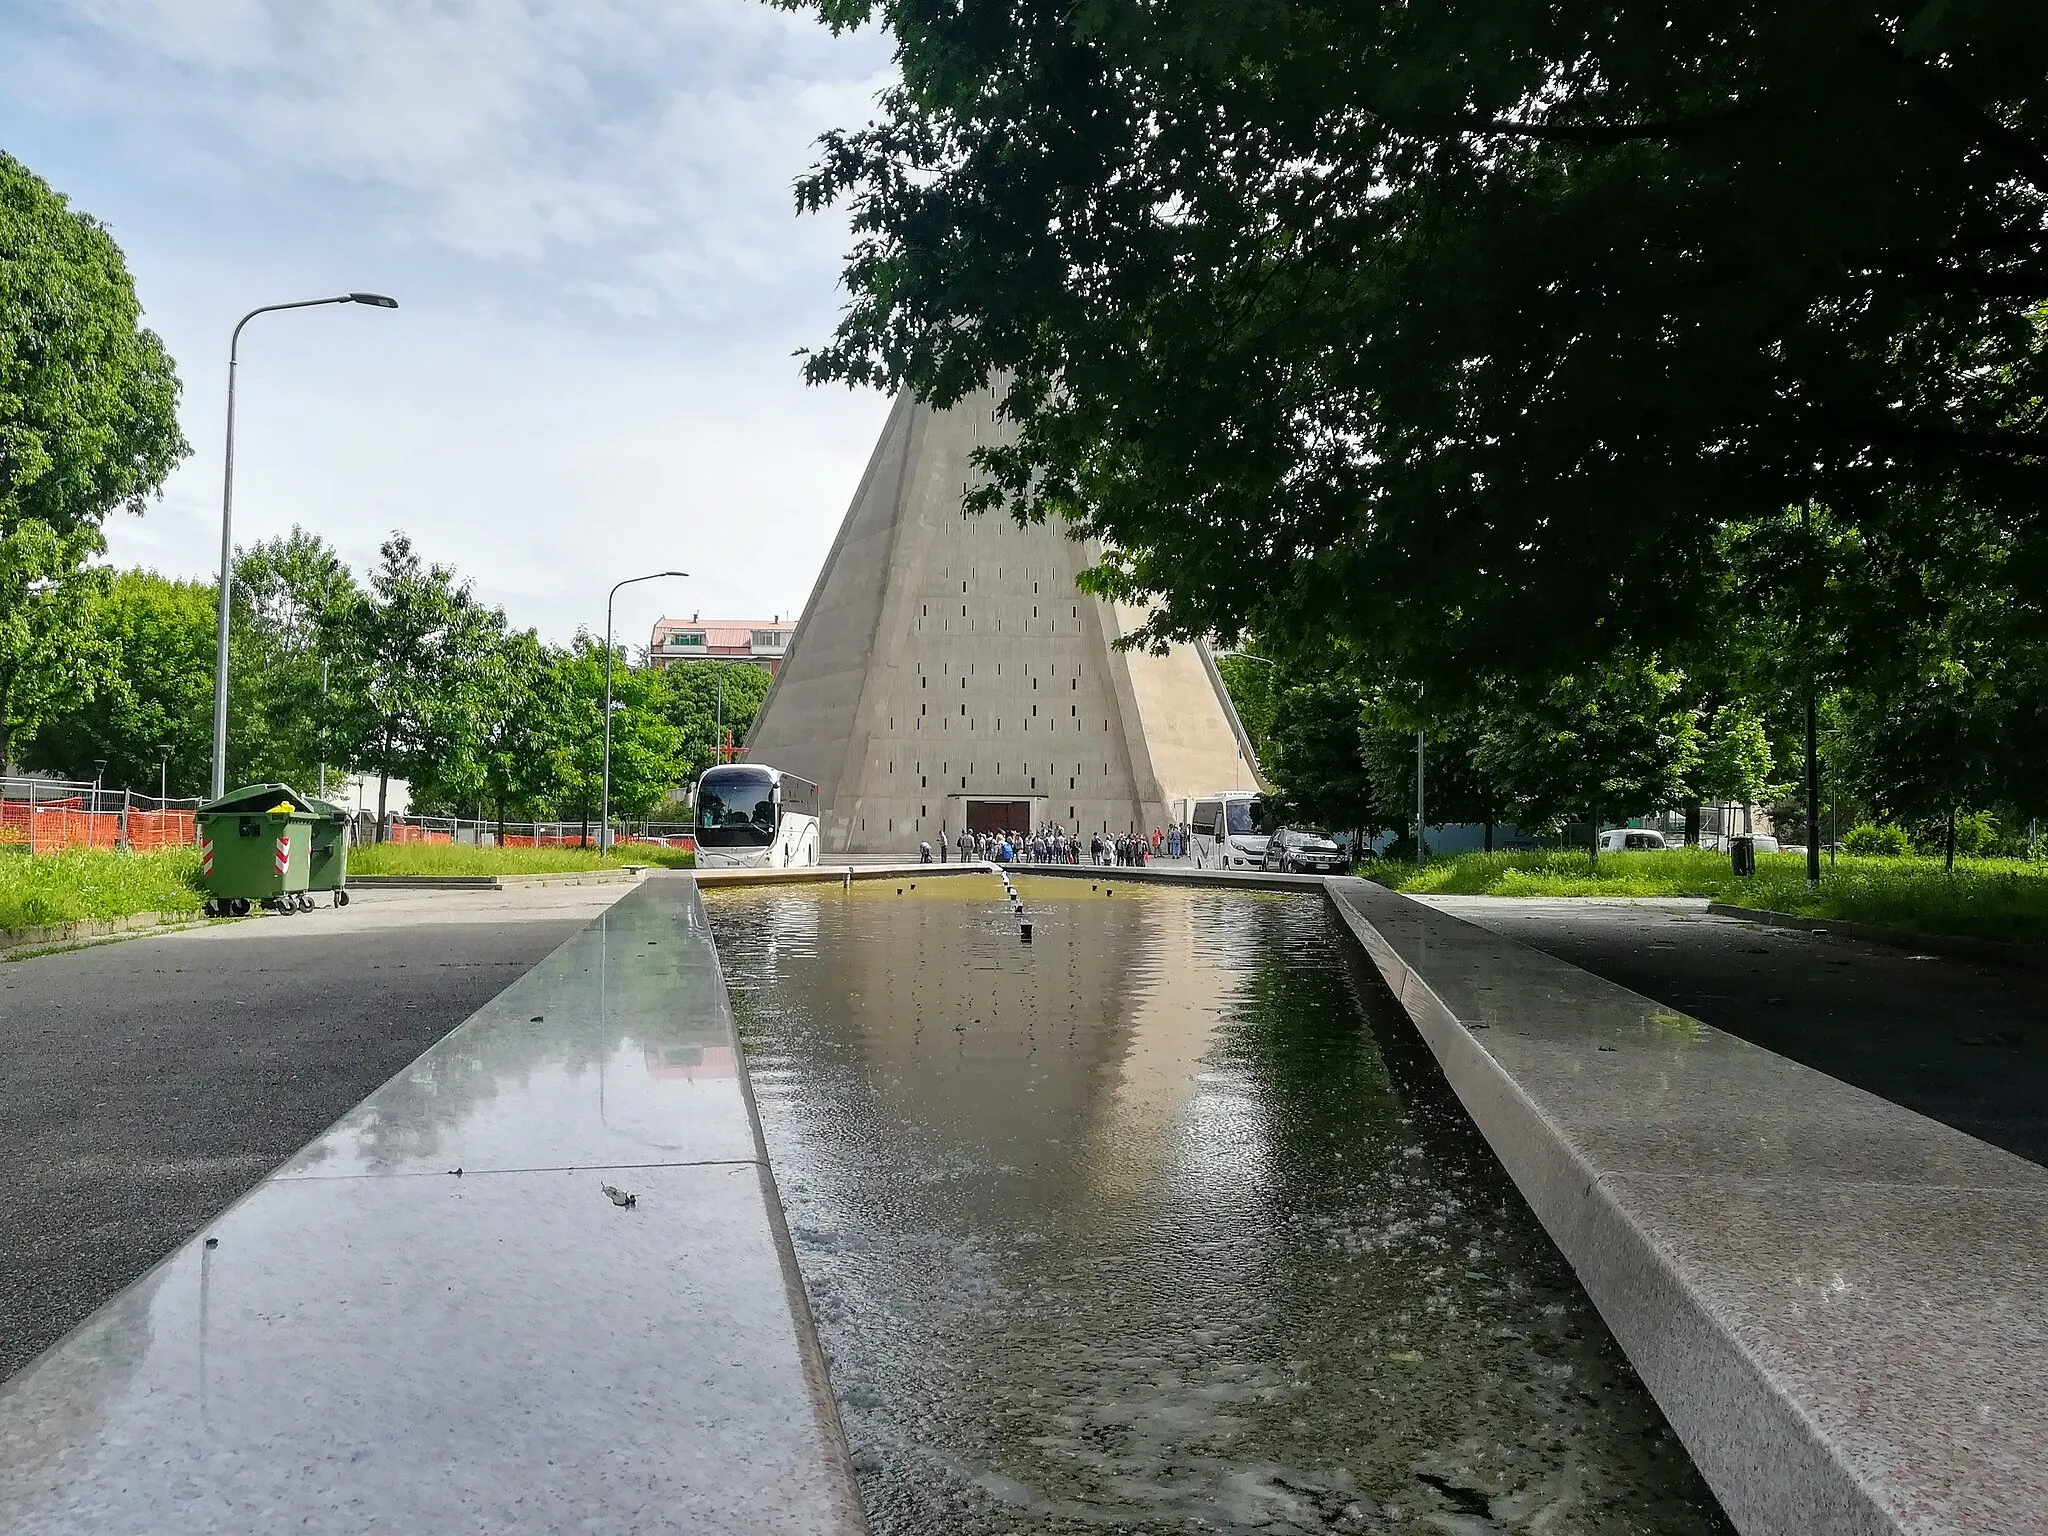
[330,532,503,838]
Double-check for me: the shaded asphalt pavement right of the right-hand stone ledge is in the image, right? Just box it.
[1425,897,2048,1165]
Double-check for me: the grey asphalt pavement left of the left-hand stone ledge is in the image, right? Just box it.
[0,885,633,1380]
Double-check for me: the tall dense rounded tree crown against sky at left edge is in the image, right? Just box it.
[0,154,190,539]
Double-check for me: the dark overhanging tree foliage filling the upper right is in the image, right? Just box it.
[788,0,2048,692]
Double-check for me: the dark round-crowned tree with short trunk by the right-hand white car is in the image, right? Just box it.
[1473,657,1700,860]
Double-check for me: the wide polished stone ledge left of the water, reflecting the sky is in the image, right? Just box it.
[0,877,862,1536]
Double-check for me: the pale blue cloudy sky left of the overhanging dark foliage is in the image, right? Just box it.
[0,0,891,643]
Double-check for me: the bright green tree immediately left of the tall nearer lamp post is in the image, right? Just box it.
[27,571,213,793]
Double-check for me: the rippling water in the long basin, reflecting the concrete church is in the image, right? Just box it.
[705,874,1731,1536]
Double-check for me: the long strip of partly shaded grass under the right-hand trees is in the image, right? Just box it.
[1370,848,2048,944]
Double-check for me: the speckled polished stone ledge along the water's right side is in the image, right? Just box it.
[1327,879,2048,1536]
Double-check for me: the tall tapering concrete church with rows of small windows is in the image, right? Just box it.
[743,393,1257,856]
